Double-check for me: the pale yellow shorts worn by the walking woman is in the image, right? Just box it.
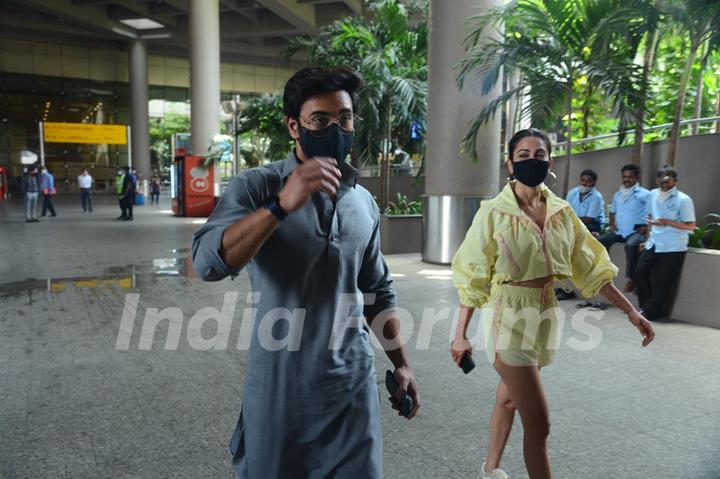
[482,284,562,367]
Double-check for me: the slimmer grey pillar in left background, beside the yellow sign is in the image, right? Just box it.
[130,40,151,178]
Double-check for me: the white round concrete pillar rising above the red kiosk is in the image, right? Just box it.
[189,0,220,155]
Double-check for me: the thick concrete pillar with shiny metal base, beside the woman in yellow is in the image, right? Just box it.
[423,0,504,264]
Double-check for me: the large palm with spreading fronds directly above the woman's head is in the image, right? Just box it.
[458,0,642,195]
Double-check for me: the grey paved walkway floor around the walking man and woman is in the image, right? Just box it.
[0,196,720,479]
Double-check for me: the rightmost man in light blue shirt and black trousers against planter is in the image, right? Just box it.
[635,166,695,321]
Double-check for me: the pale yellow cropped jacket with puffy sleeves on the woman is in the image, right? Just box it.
[452,183,618,308]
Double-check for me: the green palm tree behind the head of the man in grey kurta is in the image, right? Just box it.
[286,0,427,209]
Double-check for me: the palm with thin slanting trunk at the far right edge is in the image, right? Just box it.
[663,0,720,166]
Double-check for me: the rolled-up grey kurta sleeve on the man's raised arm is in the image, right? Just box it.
[192,173,257,281]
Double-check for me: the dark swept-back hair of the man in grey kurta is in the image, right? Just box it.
[283,66,362,118]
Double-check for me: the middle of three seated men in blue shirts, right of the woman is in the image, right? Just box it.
[598,165,650,292]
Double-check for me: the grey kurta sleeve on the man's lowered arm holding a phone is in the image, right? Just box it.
[358,207,397,318]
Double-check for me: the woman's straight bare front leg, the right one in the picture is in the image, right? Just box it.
[494,356,552,479]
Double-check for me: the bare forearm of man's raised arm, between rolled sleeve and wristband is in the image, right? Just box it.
[220,208,280,268]
